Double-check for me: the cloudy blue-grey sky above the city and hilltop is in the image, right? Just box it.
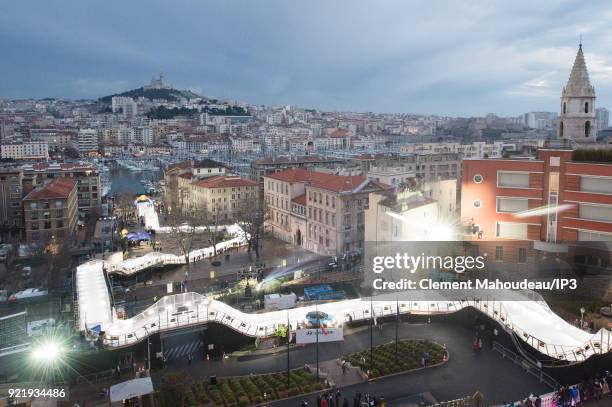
[0,0,612,116]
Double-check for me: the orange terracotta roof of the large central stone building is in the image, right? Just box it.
[266,168,386,192]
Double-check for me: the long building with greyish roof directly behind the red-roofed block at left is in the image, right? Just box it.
[22,163,102,217]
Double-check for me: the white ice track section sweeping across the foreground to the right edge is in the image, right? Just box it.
[77,201,612,362]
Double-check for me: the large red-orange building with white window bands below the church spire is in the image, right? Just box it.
[461,147,612,243]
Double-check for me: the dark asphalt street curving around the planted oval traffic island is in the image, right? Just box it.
[154,321,550,406]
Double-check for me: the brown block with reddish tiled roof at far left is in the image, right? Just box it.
[23,177,78,244]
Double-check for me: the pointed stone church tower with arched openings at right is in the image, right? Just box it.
[558,41,597,143]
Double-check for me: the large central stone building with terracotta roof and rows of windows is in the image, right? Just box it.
[264,168,387,256]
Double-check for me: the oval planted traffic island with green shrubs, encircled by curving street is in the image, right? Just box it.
[344,339,448,379]
